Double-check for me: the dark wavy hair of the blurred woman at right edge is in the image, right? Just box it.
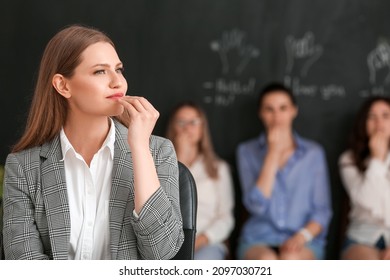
[349,96,390,172]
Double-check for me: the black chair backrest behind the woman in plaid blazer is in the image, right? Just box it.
[172,162,198,260]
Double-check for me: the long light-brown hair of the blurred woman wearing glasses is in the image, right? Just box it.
[166,101,219,179]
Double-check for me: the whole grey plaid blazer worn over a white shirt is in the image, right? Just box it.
[3,121,184,260]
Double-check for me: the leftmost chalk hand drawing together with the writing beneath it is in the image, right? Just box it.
[202,28,260,106]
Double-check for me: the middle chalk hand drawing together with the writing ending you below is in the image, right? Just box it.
[284,31,346,100]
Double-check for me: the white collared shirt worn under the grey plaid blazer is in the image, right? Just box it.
[60,120,115,260]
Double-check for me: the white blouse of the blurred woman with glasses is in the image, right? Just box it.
[189,157,234,244]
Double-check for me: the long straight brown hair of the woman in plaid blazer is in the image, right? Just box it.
[12,25,128,152]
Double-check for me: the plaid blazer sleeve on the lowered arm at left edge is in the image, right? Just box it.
[3,154,49,260]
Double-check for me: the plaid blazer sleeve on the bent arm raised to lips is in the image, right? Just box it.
[132,136,184,259]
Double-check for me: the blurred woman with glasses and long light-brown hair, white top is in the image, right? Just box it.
[167,102,234,260]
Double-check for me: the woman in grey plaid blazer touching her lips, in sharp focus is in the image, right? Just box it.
[3,25,184,259]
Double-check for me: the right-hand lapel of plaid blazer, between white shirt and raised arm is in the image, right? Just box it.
[109,121,134,260]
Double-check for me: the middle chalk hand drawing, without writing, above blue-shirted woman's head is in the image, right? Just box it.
[285,32,323,76]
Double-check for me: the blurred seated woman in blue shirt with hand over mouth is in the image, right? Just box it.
[237,83,332,260]
